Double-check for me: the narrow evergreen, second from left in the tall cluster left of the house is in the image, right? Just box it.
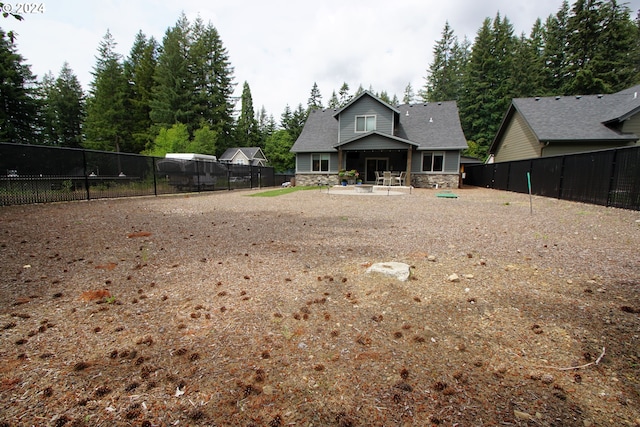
[124,31,158,153]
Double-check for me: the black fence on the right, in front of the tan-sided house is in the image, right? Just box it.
[464,147,640,210]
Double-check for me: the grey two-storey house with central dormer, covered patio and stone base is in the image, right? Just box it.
[291,91,467,187]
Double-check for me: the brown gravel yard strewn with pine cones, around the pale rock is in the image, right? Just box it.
[0,188,640,427]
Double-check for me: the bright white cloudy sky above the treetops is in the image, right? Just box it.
[5,0,640,120]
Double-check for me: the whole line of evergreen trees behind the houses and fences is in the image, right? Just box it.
[0,0,640,171]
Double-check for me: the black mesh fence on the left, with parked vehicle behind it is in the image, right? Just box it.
[0,143,293,206]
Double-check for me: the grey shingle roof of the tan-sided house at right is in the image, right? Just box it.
[489,86,640,153]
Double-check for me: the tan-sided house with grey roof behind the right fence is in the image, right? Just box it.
[489,86,640,163]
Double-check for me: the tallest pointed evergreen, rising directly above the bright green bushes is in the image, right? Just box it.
[149,13,195,128]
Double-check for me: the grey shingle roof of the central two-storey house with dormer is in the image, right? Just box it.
[291,91,468,153]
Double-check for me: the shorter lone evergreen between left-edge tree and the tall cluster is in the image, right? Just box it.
[40,62,85,148]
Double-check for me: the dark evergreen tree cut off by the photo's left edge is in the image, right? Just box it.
[0,28,40,144]
